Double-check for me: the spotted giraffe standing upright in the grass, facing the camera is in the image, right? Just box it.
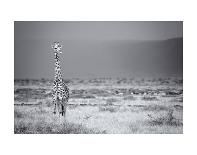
[52,42,69,117]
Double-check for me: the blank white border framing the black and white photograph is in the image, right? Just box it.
[0,0,197,155]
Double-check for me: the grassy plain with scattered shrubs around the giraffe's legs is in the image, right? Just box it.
[14,78,183,134]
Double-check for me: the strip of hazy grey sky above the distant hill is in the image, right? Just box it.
[15,22,182,40]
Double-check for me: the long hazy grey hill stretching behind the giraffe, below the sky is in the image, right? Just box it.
[15,38,183,78]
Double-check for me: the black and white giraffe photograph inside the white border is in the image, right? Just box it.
[14,21,184,134]
